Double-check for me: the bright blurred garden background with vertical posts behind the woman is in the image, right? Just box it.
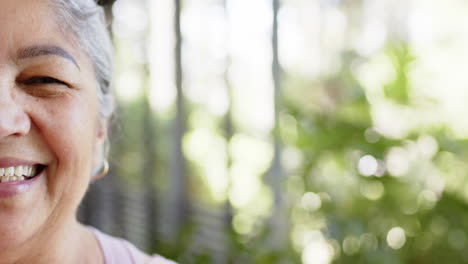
[81,0,468,264]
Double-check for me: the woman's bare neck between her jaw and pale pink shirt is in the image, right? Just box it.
[0,219,103,264]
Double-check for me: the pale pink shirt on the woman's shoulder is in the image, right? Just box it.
[90,227,176,264]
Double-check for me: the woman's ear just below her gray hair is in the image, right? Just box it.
[91,119,108,180]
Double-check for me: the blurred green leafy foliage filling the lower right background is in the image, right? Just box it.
[145,44,468,264]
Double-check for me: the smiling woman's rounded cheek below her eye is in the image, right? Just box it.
[30,96,97,176]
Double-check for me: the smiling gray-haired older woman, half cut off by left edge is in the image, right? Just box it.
[0,0,176,264]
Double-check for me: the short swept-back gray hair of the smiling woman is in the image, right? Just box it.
[50,0,114,168]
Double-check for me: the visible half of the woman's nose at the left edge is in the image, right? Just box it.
[0,92,31,140]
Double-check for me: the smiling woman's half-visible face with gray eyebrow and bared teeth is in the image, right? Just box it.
[0,0,105,252]
